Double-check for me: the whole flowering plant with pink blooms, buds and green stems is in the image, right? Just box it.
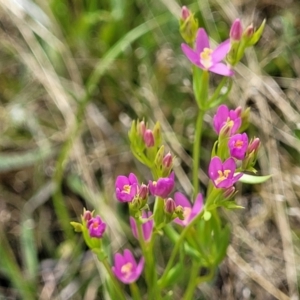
[72,7,266,300]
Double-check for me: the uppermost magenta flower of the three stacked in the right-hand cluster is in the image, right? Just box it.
[213,104,242,136]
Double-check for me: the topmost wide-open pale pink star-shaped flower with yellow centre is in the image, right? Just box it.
[181,28,234,76]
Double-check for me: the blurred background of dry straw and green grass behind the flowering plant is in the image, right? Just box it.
[0,0,300,300]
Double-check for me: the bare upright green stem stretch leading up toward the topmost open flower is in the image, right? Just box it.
[193,109,205,199]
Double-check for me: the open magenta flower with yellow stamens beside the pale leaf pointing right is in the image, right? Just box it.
[208,156,243,189]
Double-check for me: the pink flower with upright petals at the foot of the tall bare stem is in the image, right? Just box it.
[174,192,203,226]
